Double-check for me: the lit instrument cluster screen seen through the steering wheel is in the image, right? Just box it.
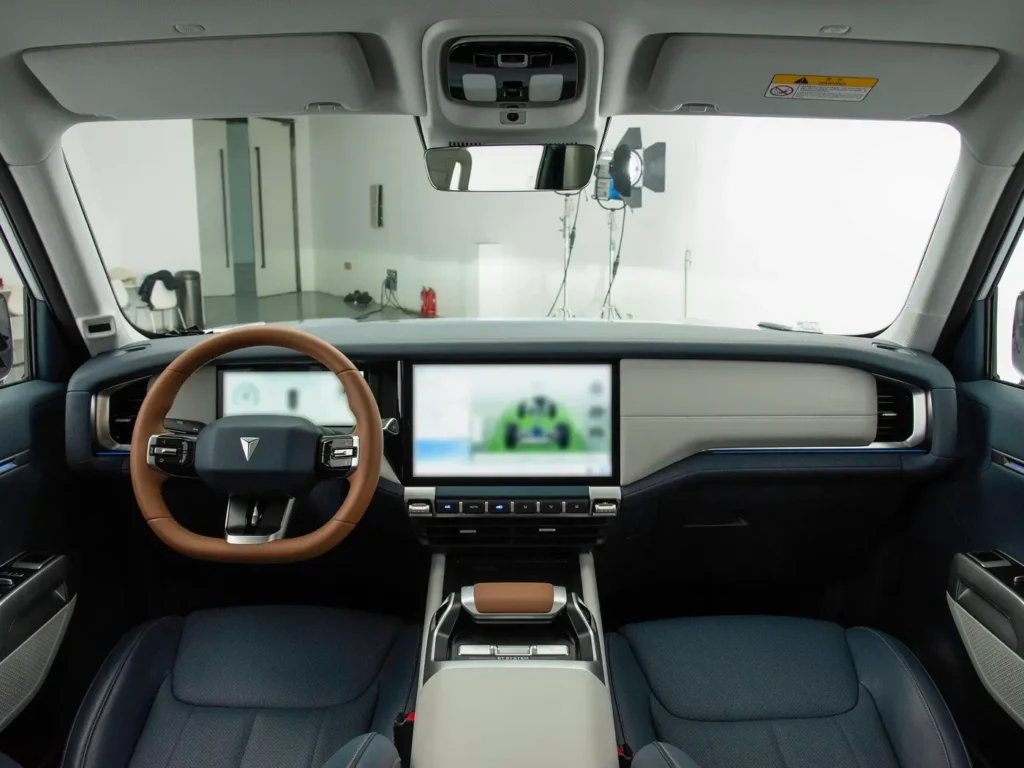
[220,370,355,427]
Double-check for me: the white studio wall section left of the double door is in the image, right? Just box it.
[62,120,200,278]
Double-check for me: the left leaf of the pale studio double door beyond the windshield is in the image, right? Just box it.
[193,120,234,296]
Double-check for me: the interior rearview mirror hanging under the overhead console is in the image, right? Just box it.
[424,144,596,191]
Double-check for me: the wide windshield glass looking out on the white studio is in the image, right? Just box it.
[63,116,959,334]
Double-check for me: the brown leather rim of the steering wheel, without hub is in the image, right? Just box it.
[129,326,383,563]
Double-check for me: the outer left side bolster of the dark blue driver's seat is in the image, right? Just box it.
[62,617,182,768]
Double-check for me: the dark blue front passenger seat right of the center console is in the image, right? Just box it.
[606,616,970,768]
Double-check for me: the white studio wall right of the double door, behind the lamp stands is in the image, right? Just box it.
[310,116,959,333]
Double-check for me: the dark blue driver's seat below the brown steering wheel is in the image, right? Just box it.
[63,606,420,768]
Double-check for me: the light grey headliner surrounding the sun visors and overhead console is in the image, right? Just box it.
[0,0,1024,165]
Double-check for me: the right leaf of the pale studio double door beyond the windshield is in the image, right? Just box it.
[249,118,298,296]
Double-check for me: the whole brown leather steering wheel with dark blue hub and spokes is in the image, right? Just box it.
[130,326,383,563]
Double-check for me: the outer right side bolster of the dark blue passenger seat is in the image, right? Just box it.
[847,627,971,768]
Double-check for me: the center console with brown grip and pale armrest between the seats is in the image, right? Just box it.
[412,555,618,768]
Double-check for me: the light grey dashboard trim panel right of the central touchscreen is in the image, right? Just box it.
[620,358,892,485]
